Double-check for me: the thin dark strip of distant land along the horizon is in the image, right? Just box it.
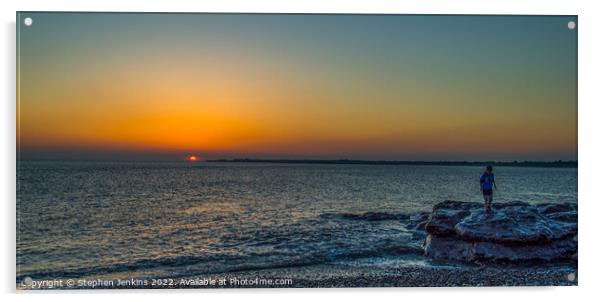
[205,158,578,168]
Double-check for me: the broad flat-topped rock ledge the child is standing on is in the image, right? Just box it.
[417,200,577,263]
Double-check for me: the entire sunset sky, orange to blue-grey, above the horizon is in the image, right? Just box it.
[17,12,577,161]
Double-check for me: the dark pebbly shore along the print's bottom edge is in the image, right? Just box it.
[17,263,578,290]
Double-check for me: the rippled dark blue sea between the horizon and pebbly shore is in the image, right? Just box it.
[16,160,577,283]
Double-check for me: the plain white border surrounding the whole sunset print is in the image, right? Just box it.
[0,0,602,302]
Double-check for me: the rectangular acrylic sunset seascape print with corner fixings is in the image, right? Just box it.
[16,12,578,290]
